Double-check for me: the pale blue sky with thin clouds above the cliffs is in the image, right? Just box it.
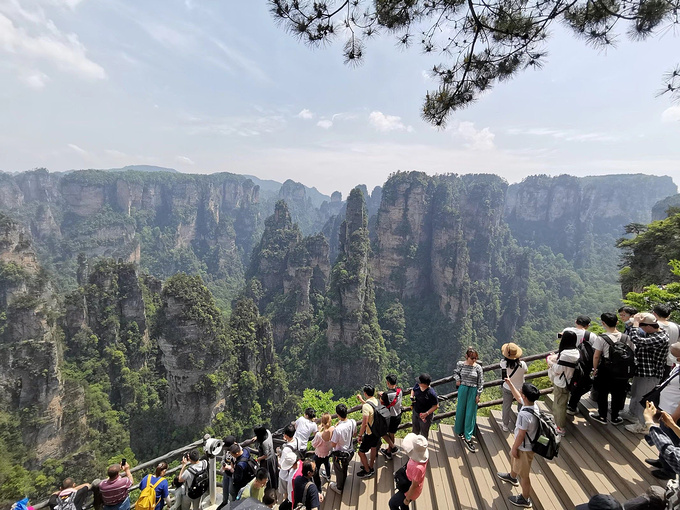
[0,0,680,195]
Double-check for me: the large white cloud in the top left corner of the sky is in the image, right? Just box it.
[0,6,106,82]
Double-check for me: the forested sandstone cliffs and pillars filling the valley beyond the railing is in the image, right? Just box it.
[0,170,677,504]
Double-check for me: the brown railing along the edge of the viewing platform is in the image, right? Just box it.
[33,351,553,510]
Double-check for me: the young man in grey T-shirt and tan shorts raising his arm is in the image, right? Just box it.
[496,379,541,508]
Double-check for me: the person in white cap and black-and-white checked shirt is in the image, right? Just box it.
[626,313,669,434]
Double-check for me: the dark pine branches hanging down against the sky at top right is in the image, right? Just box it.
[268,0,680,126]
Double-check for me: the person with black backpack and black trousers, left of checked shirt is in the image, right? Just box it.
[589,312,636,425]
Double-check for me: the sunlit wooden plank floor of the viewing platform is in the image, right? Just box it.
[322,396,664,510]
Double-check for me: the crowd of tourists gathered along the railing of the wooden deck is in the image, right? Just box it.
[38,305,680,510]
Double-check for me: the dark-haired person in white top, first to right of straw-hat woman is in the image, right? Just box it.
[547,331,580,436]
